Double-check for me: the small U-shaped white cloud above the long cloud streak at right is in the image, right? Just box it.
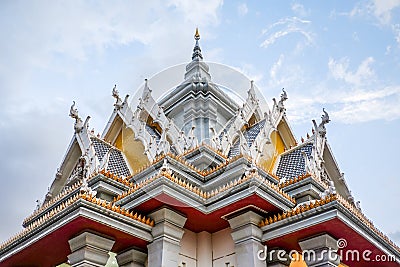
[328,57,375,86]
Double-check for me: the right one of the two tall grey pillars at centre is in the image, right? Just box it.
[228,211,266,267]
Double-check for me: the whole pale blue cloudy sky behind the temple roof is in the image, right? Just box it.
[0,0,400,247]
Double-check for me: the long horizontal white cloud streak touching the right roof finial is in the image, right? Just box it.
[288,86,400,124]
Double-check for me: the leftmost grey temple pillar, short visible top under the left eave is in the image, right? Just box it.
[68,232,115,267]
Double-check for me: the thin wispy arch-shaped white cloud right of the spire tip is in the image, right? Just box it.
[260,17,313,48]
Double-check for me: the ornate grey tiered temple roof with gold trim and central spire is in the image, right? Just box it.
[0,30,400,266]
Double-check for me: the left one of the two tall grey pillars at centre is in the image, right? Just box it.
[147,208,186,267]
